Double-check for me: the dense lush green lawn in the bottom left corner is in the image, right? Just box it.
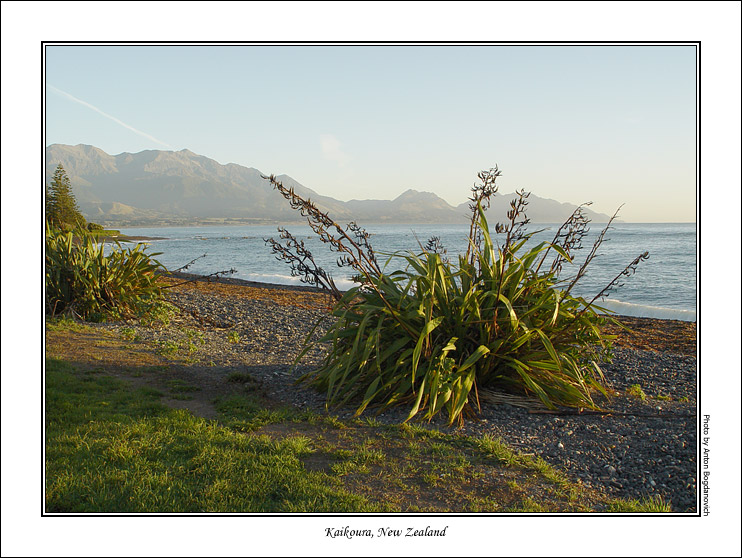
[46,359,383,513]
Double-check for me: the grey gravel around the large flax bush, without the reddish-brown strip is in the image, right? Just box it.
[113,290,698,512]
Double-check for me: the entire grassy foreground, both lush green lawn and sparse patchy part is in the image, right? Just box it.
[46,359,670,513]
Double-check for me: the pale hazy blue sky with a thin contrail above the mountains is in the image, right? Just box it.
[46,45,696,221]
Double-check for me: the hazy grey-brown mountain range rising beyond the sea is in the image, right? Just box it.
[46,144,609,227]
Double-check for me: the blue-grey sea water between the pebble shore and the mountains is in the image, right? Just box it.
[121,223,697,321]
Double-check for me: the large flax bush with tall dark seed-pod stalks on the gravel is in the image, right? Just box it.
[268,168,648,423]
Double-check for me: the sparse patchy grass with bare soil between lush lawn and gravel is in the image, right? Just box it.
[216,394,597,512]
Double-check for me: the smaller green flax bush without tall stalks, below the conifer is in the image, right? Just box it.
[45,223,164,321]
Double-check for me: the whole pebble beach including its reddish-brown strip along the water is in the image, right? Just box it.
[47,273,698,513]
